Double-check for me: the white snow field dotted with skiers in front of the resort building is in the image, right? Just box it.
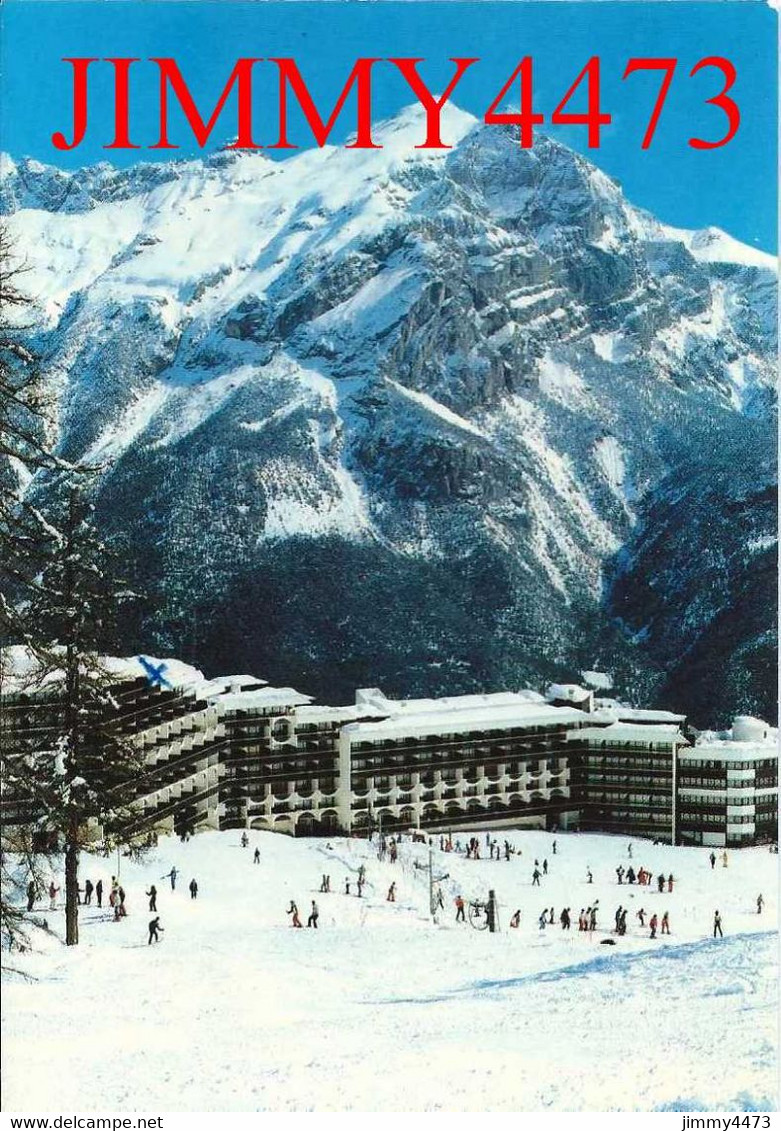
[3,830,779,1113]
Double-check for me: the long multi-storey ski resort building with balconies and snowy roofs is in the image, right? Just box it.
[2,662,778,845]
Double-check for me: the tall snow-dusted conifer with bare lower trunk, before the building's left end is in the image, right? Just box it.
[6,469,144,946]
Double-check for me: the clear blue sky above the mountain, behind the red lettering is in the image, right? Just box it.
[0,0,778,251]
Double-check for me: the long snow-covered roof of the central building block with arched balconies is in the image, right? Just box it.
[342,697,583,742]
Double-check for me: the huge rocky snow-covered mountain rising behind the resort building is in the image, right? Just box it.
[0,109,776,723]
